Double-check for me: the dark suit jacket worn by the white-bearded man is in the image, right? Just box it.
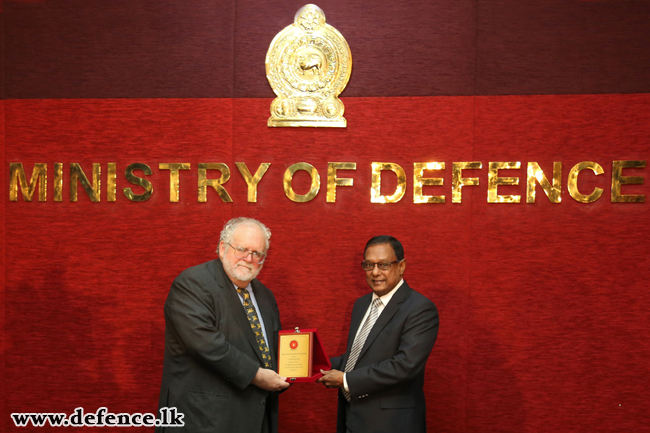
[157,259,280,433]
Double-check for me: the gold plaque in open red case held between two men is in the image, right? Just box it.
[278,328,332,383]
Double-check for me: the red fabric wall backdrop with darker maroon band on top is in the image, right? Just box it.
[0,0,650,433]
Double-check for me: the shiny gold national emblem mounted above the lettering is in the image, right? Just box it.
[266,4,352,128]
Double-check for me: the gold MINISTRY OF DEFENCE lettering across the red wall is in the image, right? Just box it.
[9,160,646,204]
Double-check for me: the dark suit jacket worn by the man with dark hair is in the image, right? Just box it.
[330,281,438,433]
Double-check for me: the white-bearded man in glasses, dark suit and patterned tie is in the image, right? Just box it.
[156,217,289,433]
